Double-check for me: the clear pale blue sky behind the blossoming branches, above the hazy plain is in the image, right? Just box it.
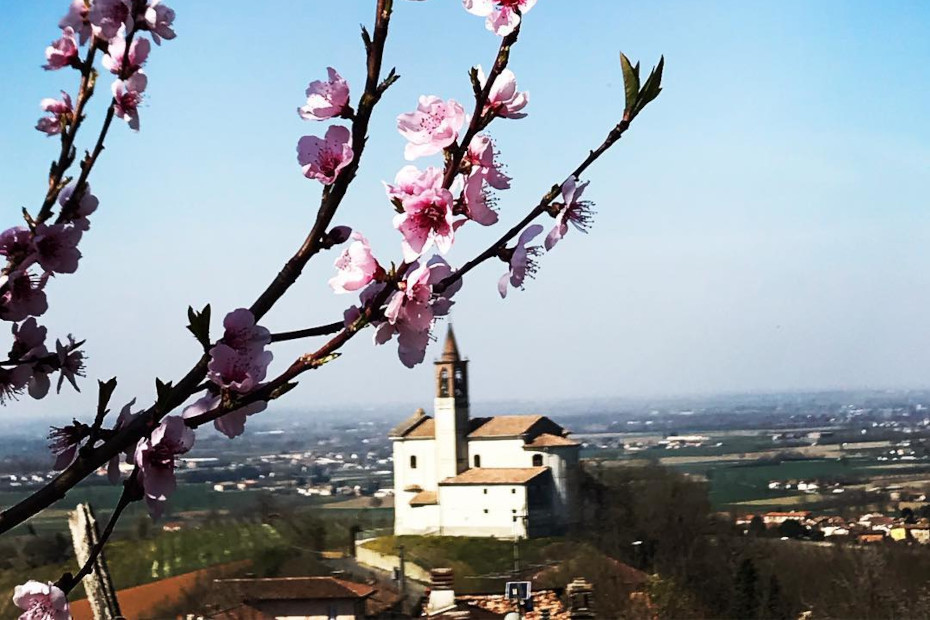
[0,0,930,422]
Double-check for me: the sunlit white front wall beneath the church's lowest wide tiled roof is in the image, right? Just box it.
[439,484,527,538]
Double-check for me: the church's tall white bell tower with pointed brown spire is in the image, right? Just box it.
[433,325,468,480]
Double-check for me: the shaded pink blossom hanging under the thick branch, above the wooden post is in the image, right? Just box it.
[135,416,194,518]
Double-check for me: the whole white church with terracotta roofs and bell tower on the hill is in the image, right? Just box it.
[390,327,580,538]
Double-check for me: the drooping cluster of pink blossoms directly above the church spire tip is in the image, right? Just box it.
[363,256,461,368]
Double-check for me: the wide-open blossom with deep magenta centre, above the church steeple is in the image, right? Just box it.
[394,171,455,262]
